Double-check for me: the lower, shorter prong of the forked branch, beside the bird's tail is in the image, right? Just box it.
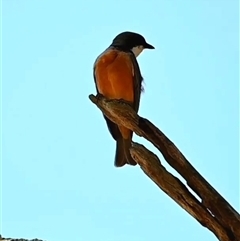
[131,143,231,241]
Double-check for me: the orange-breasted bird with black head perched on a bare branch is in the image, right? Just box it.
[93,31,155,167]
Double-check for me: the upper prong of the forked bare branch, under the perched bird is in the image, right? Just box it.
[89,95,240,241]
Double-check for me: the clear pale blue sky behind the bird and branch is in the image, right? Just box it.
[1,0,240,241]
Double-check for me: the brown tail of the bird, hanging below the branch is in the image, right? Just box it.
[114,138,137,167]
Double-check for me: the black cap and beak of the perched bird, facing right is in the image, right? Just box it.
[111,32,154,50]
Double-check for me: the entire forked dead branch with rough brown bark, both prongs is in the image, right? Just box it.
[89,95,240,241]
